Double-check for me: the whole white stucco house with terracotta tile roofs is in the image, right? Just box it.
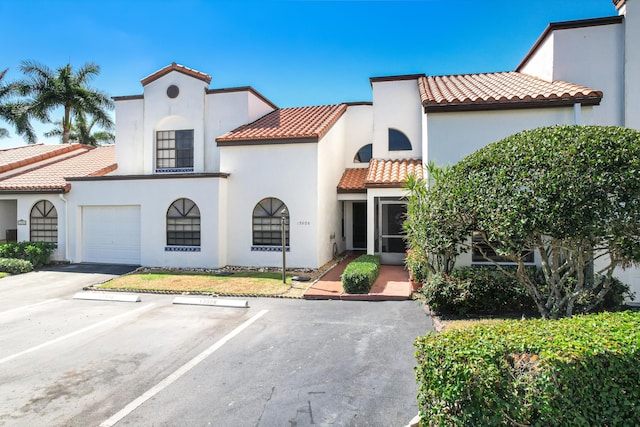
[0,0,640,300]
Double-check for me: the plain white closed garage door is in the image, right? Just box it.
[82,206,140,265]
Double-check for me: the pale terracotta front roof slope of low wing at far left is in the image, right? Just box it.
[0,145,117,193]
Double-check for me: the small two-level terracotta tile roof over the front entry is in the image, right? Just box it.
[338,159,424,193]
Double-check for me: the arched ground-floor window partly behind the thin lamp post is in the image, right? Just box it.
[253,197,289,246]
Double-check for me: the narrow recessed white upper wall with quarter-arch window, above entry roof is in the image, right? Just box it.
[339,104,373,169]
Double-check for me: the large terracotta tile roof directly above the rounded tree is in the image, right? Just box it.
[418,71,602,111]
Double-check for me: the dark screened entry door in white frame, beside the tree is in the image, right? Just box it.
[378,200,407,265]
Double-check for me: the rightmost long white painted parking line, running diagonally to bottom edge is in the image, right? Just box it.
[99,310,269,427]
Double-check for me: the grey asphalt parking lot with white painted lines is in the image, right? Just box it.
[0,268,431,426]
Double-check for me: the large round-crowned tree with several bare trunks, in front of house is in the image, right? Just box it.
[430,126,640,318]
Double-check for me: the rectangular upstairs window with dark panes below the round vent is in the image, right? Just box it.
[156,129,193,169]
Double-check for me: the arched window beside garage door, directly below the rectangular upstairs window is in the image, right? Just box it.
[167,199,200,246]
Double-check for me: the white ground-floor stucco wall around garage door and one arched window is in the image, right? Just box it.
[68,177,226,268]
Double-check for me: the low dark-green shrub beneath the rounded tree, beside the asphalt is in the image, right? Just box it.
[419,266,542,314]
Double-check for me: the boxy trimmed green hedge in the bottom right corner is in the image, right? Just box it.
[416,311,640,427]
